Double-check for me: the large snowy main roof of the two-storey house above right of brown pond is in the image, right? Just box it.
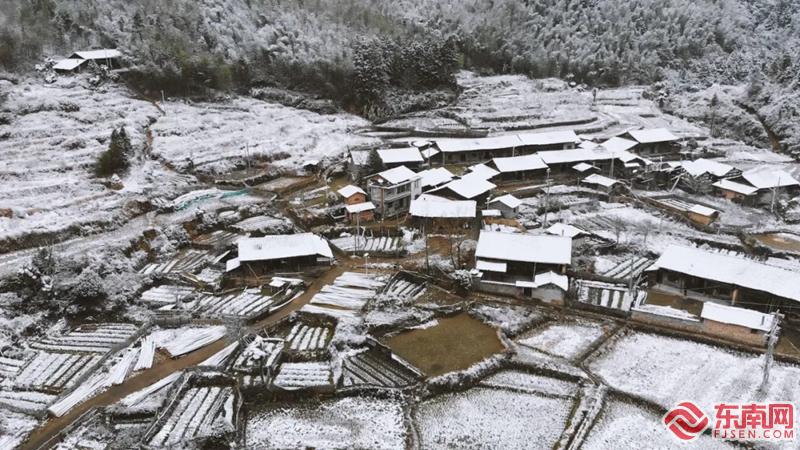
[475,231,572,264]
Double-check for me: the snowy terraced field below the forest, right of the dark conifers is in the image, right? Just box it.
[152,97,374,172]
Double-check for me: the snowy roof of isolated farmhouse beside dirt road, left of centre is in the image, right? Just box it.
[238,233,333,262]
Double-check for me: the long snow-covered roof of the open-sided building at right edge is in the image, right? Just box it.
[648,245,800,301]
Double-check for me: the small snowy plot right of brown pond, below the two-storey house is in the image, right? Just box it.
[517,321,604,359]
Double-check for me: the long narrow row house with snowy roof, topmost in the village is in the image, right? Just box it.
[436,130,580,164]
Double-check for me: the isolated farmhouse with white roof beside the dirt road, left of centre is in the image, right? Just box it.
[226,233,333,275]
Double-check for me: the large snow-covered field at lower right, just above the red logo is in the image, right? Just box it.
[589,333,800,418]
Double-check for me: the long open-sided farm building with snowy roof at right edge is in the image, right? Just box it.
[647,246,800,311]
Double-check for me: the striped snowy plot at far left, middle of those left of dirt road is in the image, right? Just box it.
[14,351,101,392]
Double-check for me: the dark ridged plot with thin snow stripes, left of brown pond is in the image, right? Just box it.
[342,350,420,388]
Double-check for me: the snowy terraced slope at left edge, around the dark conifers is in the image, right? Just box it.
[0,77,173,246]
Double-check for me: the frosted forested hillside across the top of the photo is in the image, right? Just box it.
[0,0,800,127]
